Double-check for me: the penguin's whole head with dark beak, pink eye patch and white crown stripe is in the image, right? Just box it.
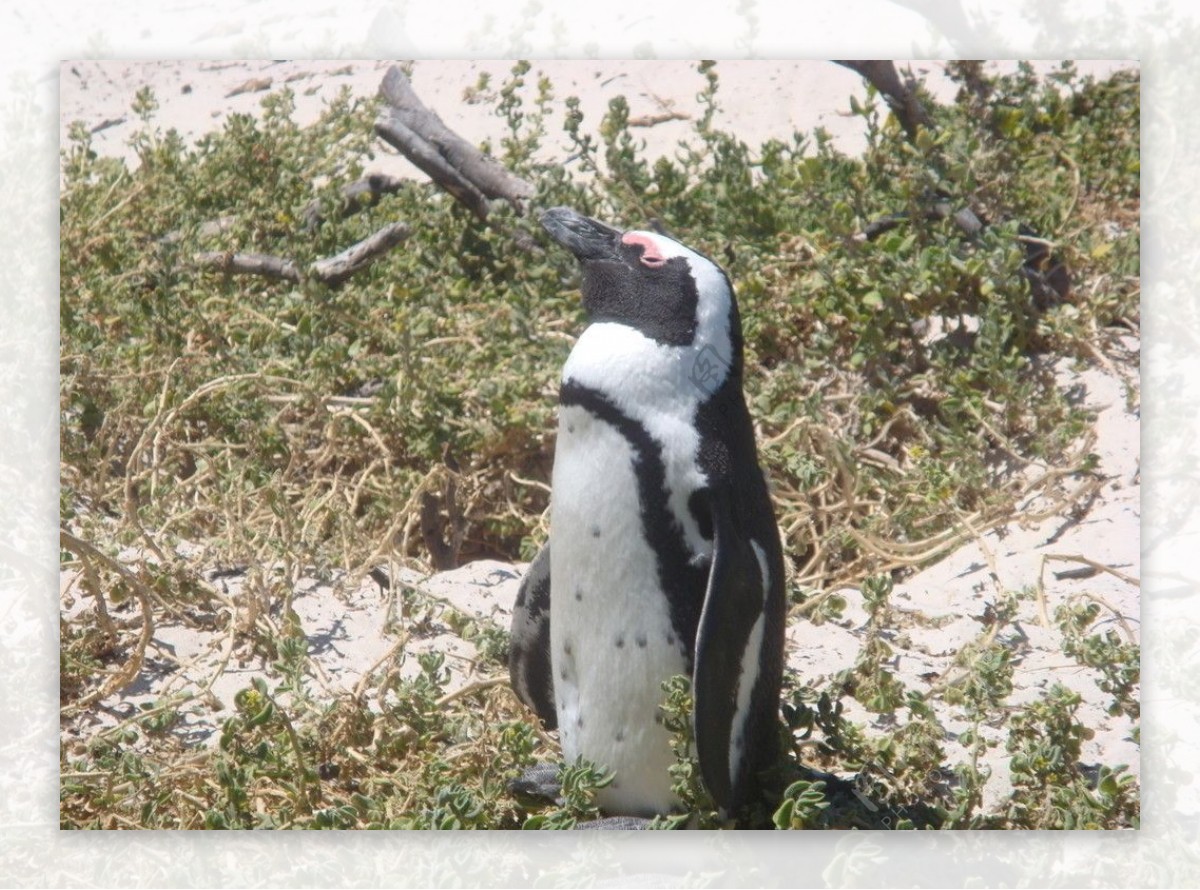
[541,208,740,359]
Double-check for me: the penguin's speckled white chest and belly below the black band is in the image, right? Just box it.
[551,405,703,813]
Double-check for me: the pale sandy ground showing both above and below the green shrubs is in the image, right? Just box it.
[61,55,1140,820]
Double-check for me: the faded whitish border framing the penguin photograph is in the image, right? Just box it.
[0,0,1200,886]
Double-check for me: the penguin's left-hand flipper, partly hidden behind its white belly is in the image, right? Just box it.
[509,542,558,729]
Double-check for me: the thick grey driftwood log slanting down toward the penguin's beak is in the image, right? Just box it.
[376,66,534,220]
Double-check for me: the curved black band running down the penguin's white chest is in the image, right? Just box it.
[559,380,712,672]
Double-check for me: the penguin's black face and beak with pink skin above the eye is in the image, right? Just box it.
[541,208,700,345]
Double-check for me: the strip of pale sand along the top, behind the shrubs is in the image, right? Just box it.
[59,60,1132,175]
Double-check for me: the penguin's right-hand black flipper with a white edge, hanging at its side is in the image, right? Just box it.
[692,494,784,814]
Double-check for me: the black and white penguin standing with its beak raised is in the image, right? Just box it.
[510,208,785,817]
